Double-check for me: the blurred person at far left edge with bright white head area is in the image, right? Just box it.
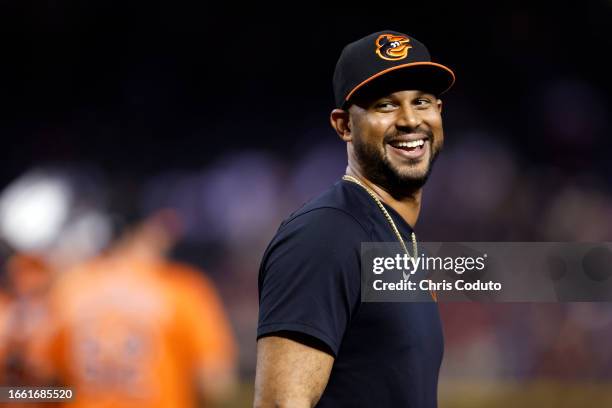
[0,166,108,406]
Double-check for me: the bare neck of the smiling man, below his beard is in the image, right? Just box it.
[346,164,423,228]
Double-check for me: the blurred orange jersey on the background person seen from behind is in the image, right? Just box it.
[44,260,235,408]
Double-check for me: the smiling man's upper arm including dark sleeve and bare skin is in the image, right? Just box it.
[255,208,367,407]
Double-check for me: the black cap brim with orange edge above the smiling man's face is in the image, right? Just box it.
[344,62,455,104]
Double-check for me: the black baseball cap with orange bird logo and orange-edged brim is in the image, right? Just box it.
[333,30,455,107]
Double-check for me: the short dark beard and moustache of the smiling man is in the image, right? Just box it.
[353,130,443,197]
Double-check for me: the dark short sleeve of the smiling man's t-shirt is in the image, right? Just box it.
[257,208,367,355]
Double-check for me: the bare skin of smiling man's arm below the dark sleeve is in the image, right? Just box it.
[255,336,334,408]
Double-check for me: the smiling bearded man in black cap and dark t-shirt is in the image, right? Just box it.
[255,31,454,407]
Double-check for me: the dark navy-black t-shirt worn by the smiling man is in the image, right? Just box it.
[257,181,444,408]
